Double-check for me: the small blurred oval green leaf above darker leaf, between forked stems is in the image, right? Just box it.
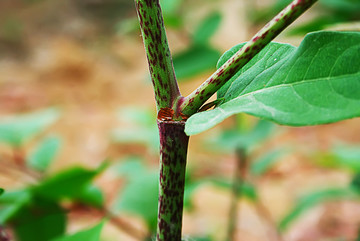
[193,12,221,45]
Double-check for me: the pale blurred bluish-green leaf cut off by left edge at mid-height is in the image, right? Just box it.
[0,109,60,147]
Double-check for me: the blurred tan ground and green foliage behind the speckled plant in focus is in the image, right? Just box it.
[0,0,360,241]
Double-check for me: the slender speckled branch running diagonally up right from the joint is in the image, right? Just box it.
[180,0,317,116]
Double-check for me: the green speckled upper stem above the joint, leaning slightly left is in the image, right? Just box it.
[135,0,180,110]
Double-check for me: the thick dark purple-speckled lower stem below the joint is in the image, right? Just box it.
[156,121,189,241]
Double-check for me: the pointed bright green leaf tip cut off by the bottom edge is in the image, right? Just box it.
[51,221,104,241]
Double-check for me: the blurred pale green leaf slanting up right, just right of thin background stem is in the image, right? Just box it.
[250,148,287,176]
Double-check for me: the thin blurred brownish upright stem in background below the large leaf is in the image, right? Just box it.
[226,148,247,241]
